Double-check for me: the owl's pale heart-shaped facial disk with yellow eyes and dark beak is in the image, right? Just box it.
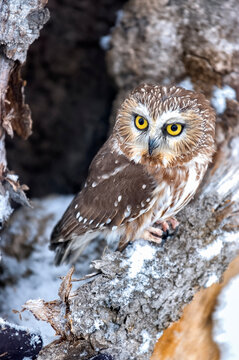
[118,106,201,166]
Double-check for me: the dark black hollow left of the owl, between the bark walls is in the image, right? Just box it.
[7,0,126,197]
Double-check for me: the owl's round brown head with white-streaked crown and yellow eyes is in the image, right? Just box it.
[114,84,215,167]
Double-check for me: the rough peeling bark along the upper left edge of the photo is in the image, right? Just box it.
[0,0,49,226]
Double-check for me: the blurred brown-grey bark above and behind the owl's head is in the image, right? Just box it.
[107,0,239,124]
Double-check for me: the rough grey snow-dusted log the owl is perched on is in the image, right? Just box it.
[25,101,239,360]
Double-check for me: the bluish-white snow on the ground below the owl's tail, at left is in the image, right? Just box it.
[0,196,103,345]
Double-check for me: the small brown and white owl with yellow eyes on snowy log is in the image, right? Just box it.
[50,84,215,264]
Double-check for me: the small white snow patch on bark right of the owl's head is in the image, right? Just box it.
[211,85,236,114]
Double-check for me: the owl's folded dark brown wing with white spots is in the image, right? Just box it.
[51,139,156,262]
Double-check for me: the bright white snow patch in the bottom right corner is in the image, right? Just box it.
[213,275,239,360]
